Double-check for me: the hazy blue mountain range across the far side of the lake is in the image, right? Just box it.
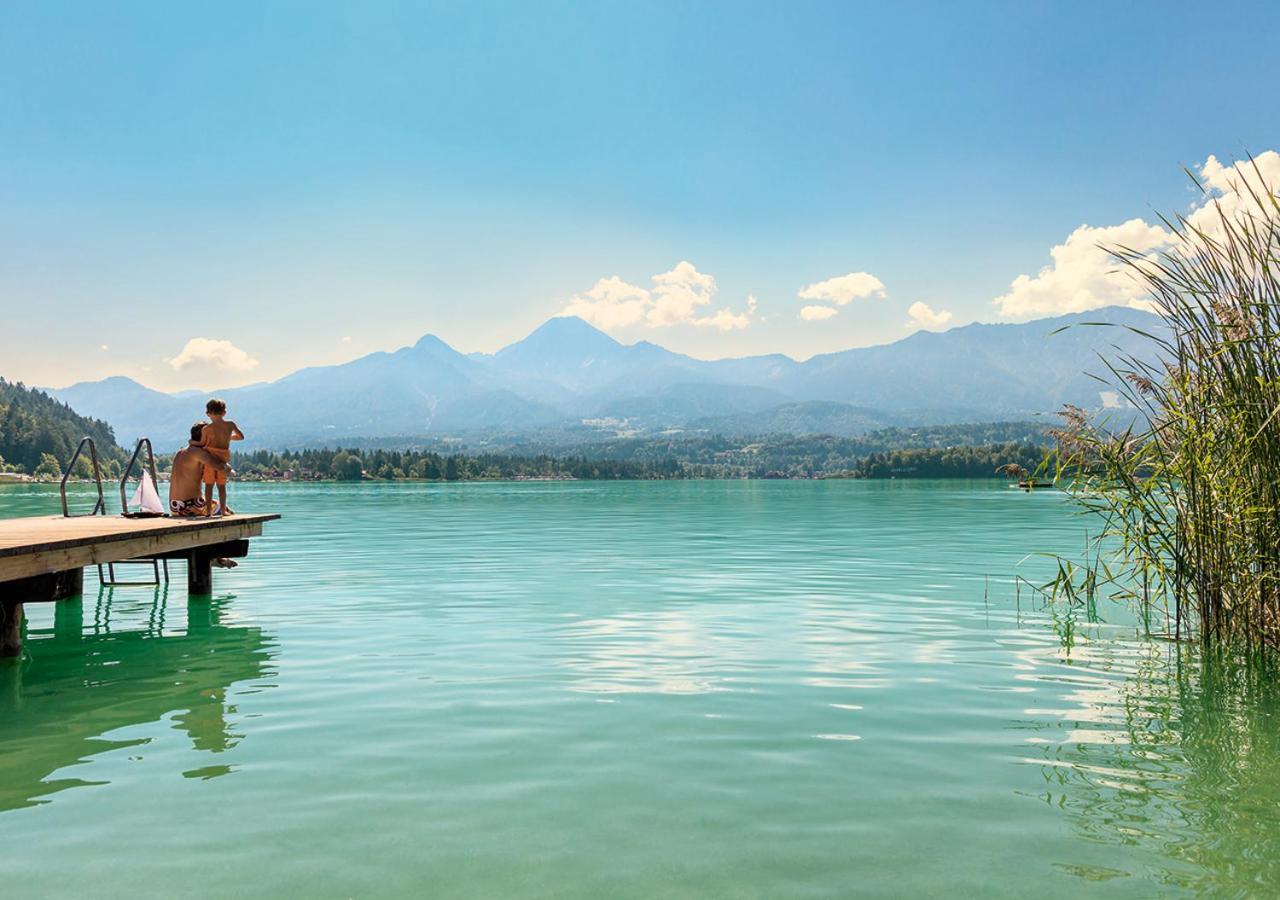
[49,307,1157,449]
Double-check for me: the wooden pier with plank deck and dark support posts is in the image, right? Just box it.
[0,515,279,657]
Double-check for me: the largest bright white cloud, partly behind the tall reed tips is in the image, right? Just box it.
[993,150,1280,319]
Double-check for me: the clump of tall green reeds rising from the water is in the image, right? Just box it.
[1047,159,1280,647]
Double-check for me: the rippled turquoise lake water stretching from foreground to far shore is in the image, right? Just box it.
[0,481,1280,897]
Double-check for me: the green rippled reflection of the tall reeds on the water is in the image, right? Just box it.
[1027,641,1280,896]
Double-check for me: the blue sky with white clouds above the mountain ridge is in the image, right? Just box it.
[0,0,1280,390]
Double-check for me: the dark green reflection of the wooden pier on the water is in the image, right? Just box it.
[0,585,273,810]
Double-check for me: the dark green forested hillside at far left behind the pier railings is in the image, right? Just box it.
[0,378,124,476]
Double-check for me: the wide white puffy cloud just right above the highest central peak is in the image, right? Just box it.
[559,260,756,332]
